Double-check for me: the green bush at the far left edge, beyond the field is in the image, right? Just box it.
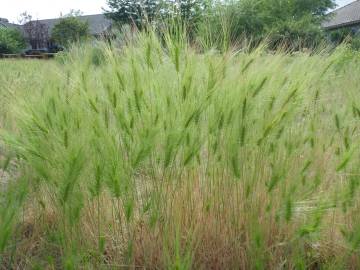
[0,27,26,54]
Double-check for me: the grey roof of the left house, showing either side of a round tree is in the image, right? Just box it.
[23,14,112,35]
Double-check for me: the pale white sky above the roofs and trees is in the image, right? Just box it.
[0,0,353,23]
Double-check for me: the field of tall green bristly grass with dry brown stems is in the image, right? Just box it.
[0,35,360,269]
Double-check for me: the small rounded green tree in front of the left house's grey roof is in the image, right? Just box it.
[51,13,90,47]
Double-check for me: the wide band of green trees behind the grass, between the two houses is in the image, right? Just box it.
[107,0,335,49]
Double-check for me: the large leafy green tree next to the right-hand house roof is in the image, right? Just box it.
[208,0,335,47]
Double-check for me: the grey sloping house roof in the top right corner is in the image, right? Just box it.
[323,0,360,30]
